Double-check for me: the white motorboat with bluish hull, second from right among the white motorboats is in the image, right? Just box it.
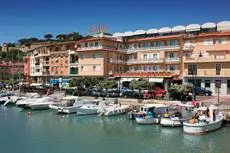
[77,102,99,115]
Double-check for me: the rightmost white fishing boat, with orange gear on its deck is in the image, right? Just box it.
[183,106,224,134]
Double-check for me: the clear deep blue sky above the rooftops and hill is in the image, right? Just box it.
[0,0,230,44]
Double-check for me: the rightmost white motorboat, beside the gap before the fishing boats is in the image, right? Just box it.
[98,104,129,117]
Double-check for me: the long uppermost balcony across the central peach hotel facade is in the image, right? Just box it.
[127,45,180,53]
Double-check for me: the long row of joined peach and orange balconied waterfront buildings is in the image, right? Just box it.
[24,21,230,95]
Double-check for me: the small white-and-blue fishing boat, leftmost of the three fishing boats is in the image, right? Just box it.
[134,104,168,124]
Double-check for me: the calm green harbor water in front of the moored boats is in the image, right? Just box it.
[0,106,230,153]
